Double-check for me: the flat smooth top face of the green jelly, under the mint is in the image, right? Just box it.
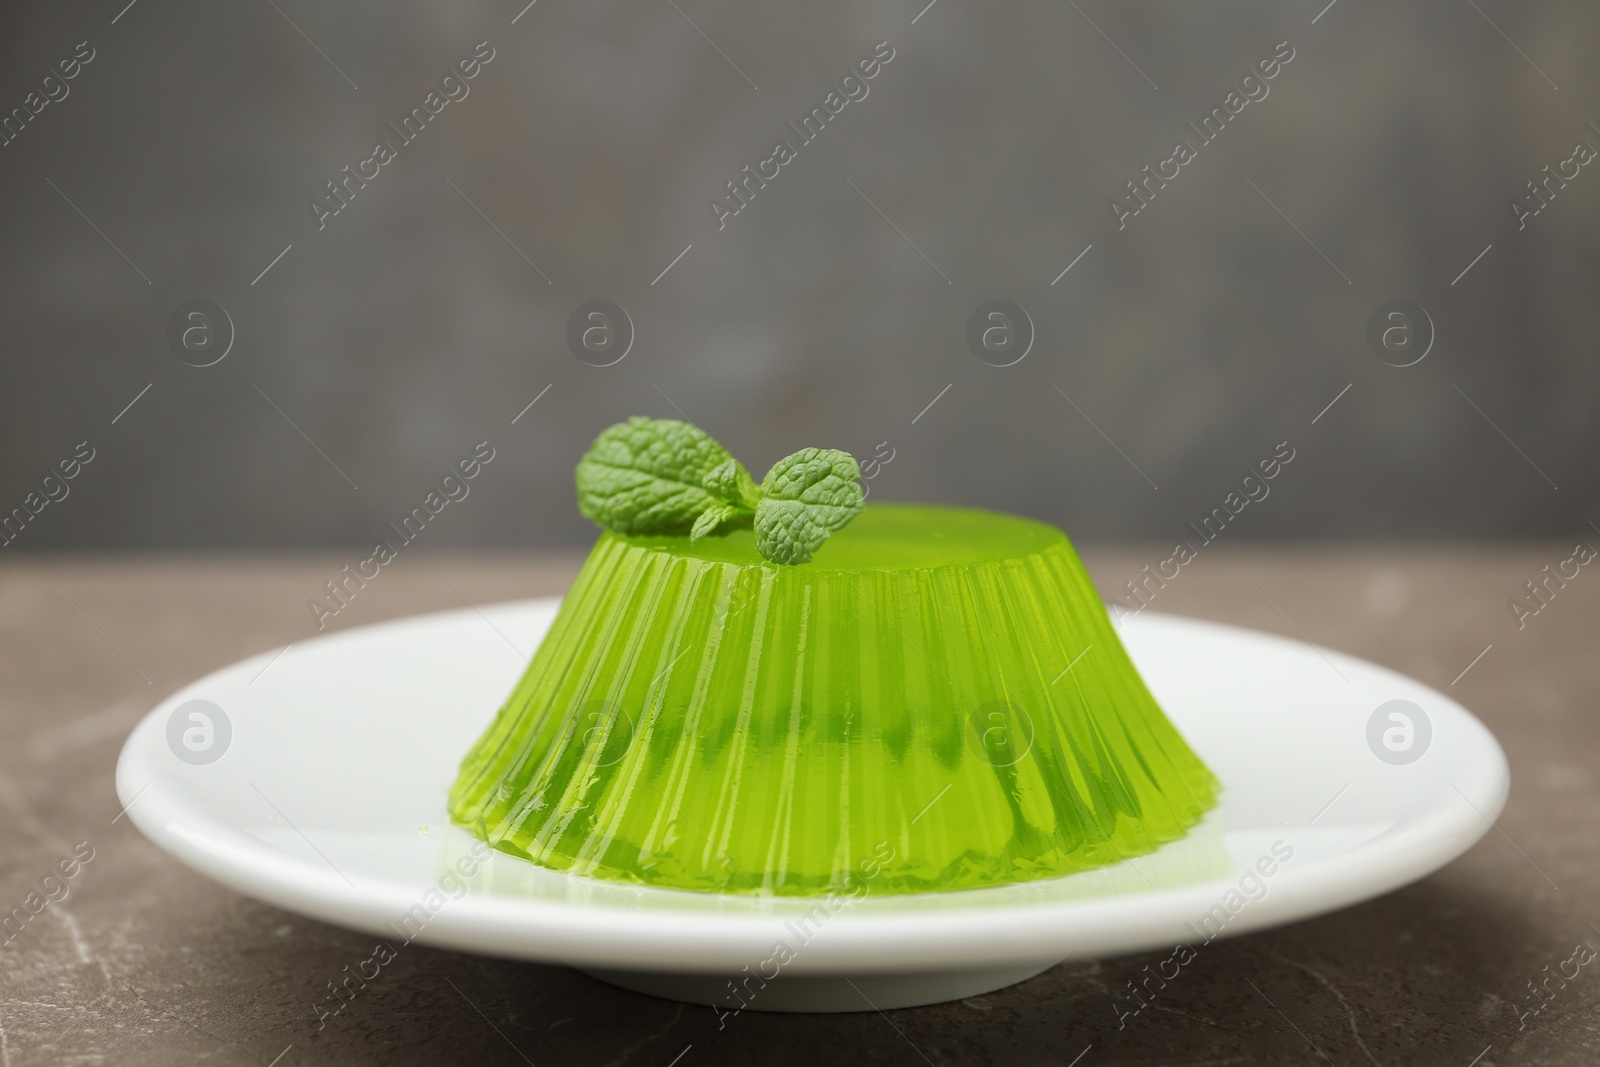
[608,504,1066,571]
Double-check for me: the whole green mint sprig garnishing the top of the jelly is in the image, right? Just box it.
[576,416,866,563]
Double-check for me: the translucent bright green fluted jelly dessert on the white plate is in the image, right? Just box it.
[450,424,1219,896]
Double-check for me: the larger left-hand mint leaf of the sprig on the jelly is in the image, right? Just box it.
[576,416,749,534]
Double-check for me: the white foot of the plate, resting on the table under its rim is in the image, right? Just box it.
[582,960,1056,1011]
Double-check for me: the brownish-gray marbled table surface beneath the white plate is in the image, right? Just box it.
[0,544,1600,1067]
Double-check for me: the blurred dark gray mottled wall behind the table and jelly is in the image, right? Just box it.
[0,0,1600,552]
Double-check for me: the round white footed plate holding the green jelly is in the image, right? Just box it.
[117,600,1509,1011]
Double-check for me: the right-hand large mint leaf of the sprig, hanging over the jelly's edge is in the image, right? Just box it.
[755,448,866,563]
